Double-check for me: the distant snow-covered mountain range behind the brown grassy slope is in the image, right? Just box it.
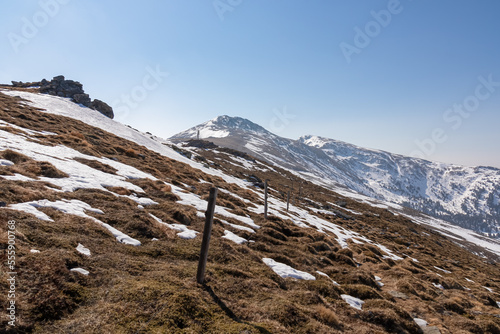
[171,116,500,236]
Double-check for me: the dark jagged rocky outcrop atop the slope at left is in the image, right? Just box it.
[12,75,114,118]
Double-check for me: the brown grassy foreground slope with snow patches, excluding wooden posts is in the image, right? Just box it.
[0,91,500,334]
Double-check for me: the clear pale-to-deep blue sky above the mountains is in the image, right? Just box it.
[0,0,500,167]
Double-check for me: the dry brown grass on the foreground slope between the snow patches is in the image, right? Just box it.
[0,90,500,334]
